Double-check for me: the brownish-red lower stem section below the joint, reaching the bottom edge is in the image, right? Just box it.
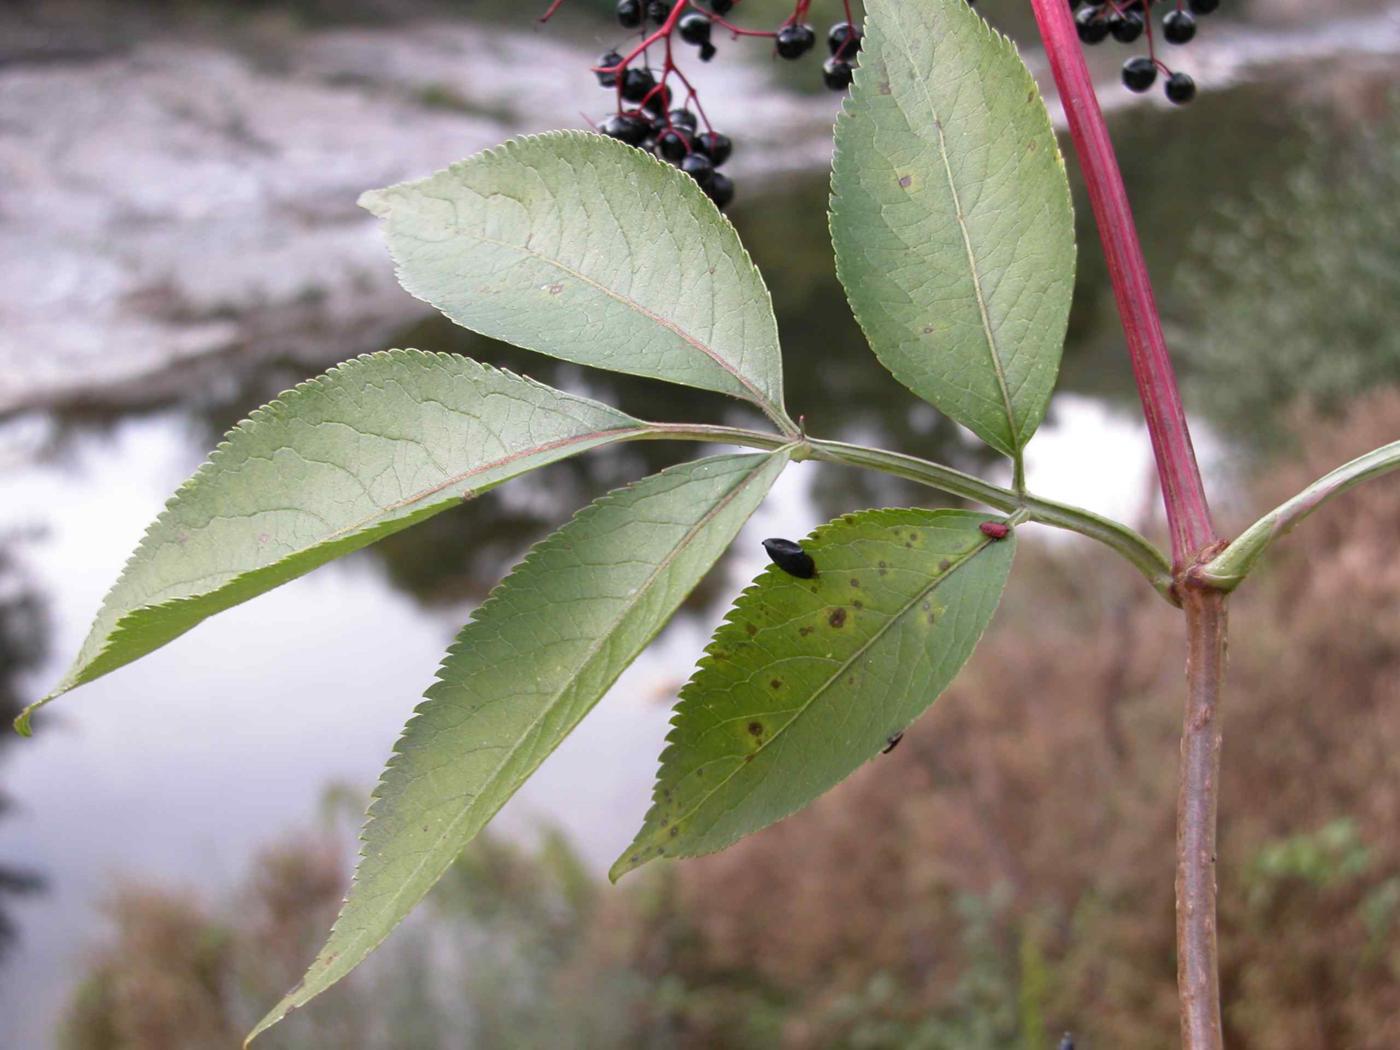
[1176,585,1226,1050]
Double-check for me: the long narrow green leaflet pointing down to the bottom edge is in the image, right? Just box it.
[249,449,788,1040]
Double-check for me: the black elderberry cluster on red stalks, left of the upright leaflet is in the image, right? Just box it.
[557,0,861,209]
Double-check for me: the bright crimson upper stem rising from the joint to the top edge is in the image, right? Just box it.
[1030,0,1215,571]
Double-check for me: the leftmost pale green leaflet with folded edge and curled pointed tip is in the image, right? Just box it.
[15,350,645,732]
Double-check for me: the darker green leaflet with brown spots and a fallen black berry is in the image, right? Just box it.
[609,510,1015,879]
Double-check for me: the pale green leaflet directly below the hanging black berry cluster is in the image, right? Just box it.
[360,132,795,431]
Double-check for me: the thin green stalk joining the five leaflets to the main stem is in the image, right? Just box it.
[637,423,1177,605]
